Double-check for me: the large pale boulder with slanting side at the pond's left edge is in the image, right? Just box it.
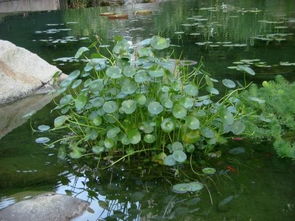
[0,40,61,104]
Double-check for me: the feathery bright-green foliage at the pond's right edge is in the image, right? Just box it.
[239,76,295,159]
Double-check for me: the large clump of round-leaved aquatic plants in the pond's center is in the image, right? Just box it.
[54,36,247,166]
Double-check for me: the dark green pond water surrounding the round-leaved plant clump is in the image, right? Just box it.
[0,0,295,221]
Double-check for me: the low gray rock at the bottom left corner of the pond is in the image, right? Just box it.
[0,193,89,221]
